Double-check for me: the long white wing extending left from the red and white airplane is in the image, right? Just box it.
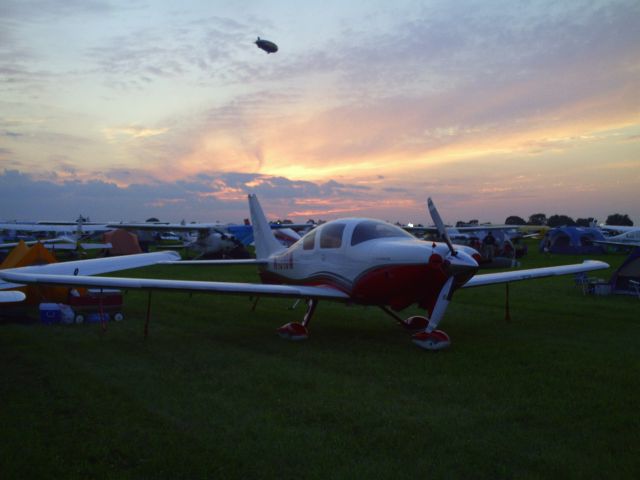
[0,270,349,300]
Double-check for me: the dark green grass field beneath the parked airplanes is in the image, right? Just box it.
[0,244,640,479]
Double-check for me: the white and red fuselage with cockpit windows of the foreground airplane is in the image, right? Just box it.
[260,218,479,310]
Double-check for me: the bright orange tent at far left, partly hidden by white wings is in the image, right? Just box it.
[0,240,69,305]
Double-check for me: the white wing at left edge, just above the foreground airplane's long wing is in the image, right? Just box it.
[0,251,180,290]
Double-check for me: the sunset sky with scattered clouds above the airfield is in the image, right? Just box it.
[0,0,640,225]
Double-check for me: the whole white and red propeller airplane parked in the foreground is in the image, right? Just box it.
[0,195,609,350]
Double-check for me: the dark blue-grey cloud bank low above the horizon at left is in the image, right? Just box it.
[0,170,376,221]
